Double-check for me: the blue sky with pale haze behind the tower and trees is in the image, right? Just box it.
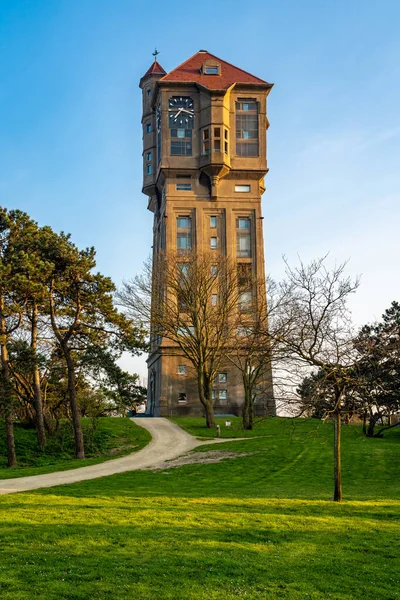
[0,0,400,370]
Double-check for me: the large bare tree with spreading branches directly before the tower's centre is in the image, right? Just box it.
[118,252,239,427]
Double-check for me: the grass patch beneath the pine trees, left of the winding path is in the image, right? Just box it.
[0,417,151,479]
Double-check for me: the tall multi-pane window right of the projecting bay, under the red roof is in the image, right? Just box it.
[236,100,258,157]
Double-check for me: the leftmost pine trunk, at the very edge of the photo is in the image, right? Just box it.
[0,296,17,467]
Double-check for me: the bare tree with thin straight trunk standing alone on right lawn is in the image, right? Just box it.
[270,256,359,502]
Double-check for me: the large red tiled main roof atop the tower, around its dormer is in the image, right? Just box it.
[160,50,272,90]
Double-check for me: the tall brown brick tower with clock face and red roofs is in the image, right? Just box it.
[140,50,275,416]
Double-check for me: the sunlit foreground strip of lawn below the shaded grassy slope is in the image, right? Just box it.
[0,495,398,600]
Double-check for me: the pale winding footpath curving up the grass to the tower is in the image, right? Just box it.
[0,417,234,494]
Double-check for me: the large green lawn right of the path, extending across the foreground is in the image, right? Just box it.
[0,419,400,600]
